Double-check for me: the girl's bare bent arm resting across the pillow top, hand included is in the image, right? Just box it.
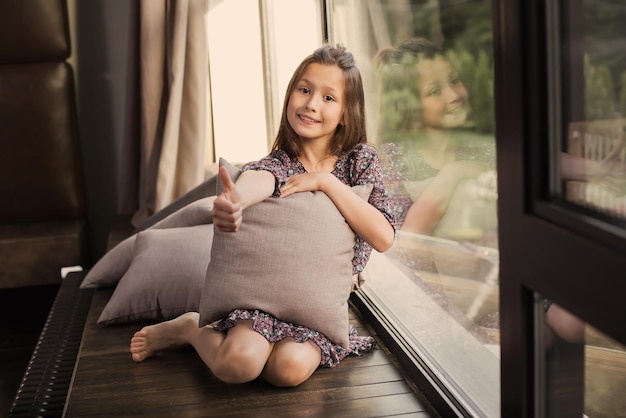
[281,172,395,252]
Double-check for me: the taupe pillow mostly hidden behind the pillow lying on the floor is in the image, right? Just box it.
[80,196,215,288]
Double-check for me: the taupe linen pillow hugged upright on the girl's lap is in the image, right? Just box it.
[200,161,372,348]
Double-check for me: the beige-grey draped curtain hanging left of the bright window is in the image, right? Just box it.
[132,0,211,226]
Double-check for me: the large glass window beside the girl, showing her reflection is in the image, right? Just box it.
[329,0,500,416]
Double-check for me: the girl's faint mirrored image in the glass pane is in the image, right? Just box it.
[376,38,495,242]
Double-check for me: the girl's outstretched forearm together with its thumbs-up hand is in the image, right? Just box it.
[212,167,276,232]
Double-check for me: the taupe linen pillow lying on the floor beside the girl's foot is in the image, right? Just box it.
[98,224,213,324]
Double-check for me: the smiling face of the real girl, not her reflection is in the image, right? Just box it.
[287,63,345,143]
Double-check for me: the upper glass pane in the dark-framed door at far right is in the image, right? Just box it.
[547,0,626,227]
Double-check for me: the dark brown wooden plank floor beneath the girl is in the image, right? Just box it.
[64,290,436,418]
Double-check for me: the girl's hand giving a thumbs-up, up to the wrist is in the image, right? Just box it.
[211,167,243,232]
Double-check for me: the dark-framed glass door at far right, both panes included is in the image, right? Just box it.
[494,0,626,418]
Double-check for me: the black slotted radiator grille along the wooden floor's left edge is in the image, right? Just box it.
[9,273,93,418]
